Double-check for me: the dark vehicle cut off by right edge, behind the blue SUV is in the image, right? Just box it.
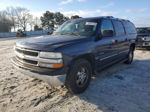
[137,27,150,48]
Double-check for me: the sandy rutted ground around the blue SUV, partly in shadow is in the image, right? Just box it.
[0,39,150,112]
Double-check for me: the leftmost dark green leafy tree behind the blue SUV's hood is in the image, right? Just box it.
[41,11,55,29]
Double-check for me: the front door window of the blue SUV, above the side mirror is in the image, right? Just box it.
[101,19,114,33]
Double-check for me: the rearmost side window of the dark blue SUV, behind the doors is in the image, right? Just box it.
[123,21,136,34]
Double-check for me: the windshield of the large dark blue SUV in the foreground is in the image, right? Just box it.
[54,19,98,36]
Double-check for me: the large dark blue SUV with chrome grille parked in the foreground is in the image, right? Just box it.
[13,17,137,94]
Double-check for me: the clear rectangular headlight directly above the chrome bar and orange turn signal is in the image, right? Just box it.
[39,52,62,59]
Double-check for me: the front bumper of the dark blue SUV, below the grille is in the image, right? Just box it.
[12,57,67,86]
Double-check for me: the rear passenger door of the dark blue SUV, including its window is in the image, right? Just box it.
[113,20,129,59]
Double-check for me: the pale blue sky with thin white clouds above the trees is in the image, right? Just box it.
[0,0,150,26]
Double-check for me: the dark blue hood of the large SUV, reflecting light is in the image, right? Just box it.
[16,35,87,51]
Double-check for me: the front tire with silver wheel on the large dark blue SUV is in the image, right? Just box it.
[65,59,92,94]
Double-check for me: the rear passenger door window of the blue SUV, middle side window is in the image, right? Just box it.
[113,20,125,36]
